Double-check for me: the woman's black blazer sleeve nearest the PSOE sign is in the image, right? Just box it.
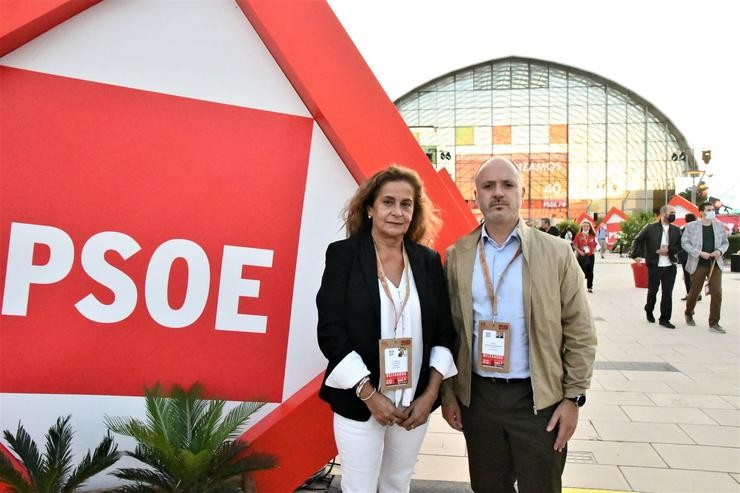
[316,242,353,368]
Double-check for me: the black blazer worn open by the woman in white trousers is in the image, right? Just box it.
[316,231,455,421]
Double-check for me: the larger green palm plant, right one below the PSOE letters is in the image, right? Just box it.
[105,384,276,493]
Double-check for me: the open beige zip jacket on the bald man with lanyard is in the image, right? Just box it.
[442,220,596,412]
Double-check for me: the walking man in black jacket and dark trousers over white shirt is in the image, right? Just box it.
[630,204,681,329]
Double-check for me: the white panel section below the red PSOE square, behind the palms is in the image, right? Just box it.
[0,394,277,490]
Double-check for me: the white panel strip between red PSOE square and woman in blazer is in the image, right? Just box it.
[283,123,357,401]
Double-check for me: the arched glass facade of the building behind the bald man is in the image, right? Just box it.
[396,58,696,218]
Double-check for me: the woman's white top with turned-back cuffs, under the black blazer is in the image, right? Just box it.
[326,266,457,406]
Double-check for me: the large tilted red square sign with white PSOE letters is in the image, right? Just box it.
[0,67,313,402]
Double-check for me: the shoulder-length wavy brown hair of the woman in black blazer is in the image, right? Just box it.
[344,164,442,245]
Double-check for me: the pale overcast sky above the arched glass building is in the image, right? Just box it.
[329,0,740,208]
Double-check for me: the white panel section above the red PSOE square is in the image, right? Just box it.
[0,0,310,116]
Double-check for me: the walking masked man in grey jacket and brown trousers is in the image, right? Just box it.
[681,202,730,334]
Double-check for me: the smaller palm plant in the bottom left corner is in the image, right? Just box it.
[0,416,121,493]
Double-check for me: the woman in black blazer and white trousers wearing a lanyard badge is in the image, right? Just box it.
[316,166,457,493]
